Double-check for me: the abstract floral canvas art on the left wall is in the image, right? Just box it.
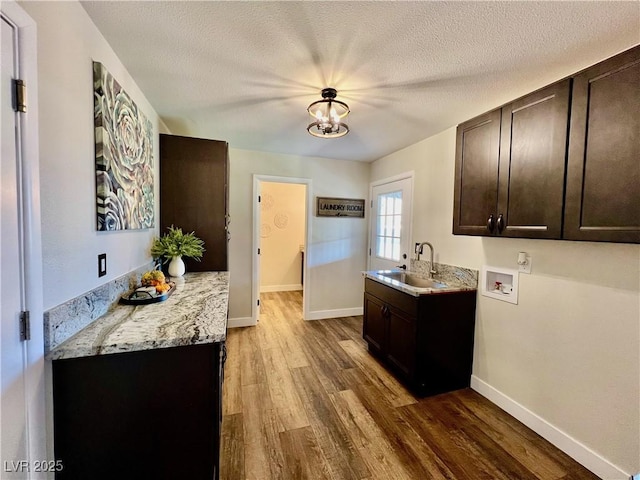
[93,62,154,231]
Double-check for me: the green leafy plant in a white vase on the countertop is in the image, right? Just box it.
[151,225,205,277]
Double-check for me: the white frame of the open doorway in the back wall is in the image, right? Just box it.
[251,174,313,325]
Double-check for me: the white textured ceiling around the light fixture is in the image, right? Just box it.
[82,1,640,161]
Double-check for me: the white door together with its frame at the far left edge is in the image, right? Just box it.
[0,2,47,479]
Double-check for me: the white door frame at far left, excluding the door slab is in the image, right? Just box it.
[0,1,45,478]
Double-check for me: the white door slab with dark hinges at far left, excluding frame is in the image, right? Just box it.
[0,14,29,479]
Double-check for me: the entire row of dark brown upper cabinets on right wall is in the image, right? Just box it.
[453,46,640,243]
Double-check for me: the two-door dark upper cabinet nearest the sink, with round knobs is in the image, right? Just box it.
[453,80,570,238]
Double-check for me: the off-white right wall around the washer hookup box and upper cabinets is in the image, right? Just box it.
[371,127,640,478]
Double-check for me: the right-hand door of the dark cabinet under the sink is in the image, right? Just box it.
[387,307,417,379]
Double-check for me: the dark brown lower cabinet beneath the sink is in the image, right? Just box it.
[362,278,476,396]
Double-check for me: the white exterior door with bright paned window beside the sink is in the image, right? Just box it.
[369,177,413,270]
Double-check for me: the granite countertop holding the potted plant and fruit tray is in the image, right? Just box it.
[47,272,229,360]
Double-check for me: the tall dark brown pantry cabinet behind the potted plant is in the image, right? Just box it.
[160,134,229,272]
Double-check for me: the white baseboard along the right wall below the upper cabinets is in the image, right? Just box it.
[471,375,631,480]
